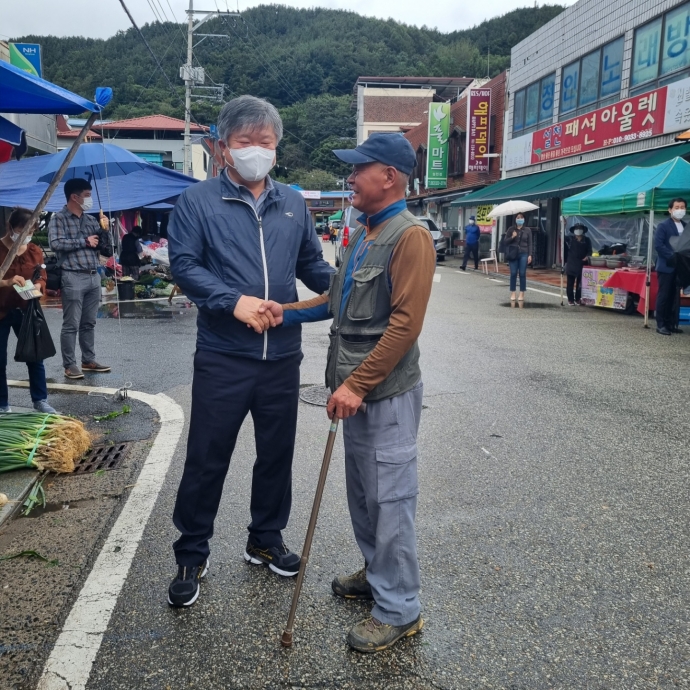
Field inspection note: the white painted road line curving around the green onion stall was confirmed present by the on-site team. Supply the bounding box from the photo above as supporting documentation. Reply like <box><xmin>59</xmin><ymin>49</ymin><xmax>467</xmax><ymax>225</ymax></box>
<box><xmin>14</xmin><ymin>381</ymin><xmax>184</xmax><ymax>690</ymax></box>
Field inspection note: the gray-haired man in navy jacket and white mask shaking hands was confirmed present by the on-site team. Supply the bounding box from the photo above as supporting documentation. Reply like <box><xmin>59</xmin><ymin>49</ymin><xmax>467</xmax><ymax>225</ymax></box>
<box><xmin>168</xmin><ymin>96</ymin><xmax>334</xmax><ymax>606</ymax></box>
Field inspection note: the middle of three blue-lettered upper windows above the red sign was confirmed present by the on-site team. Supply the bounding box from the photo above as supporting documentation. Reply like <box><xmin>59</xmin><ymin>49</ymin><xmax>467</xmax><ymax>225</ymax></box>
<box><xmin>559</xmin><ymin>36</ymin><xmax>624</xmax><ymax>120</ymax></box>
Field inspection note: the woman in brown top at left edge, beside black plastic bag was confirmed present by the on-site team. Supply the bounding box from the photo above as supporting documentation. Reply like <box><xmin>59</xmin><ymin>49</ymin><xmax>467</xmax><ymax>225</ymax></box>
<box><xmin>0</xmin><ymin>208</ymin><xmax>55</xmax><ymax>414</ymax></box>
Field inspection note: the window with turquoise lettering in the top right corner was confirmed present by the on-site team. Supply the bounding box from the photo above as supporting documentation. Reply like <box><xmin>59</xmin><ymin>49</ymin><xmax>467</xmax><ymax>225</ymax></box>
<box><xmin>630</xmin><ymin>2</ymin><xmax>690</xmax><ymax>95</ymax></box>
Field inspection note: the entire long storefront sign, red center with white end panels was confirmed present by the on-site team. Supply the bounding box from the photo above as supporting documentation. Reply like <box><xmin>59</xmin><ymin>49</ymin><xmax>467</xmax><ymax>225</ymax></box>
<box><xmin>505</xmin><ymin>78</ymin><xmax>690</xmax><ymax>170</ymax></box>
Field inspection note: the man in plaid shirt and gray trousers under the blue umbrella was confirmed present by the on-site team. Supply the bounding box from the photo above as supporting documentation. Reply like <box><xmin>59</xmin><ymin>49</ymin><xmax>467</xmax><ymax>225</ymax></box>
<box><xmin>48</xmin><ymin>178</ymin><xmax>110</xmax><ymax>379</ymax></box>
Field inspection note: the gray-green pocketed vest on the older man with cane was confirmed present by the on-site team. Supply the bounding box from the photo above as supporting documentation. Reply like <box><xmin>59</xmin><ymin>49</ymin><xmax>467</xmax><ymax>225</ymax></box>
<box><xmin>326</xmin><ymin>211</ymin><xmax>422</xmax><ymax>402</ymax></box>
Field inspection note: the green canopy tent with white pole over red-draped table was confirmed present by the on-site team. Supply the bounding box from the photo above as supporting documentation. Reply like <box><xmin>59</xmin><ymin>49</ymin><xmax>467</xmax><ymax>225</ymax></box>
<box><xmin>561</xmin><ymin>158</ymin><xmax>690</xmax><ymax>328</ymax></box>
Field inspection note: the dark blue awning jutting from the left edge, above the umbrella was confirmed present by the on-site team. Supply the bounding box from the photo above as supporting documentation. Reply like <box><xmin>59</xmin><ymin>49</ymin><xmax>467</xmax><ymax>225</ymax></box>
<box><xmin>0</xmin><ymin>61</ymin><xmax>113</xmax><ymax>115</ymax></box>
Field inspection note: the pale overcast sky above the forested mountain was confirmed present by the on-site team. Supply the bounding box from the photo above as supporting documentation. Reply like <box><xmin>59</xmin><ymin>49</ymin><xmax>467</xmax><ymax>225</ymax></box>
<box><xmin>0</xmin><ymin>0</ymin><xmax>575</xmax><ymax>40</ymax></box>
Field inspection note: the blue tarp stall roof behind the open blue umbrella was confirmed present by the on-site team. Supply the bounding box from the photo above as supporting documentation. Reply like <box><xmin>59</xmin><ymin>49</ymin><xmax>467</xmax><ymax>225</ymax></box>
<box><xmin>0</xmin><ymin>154</ymin><xmax>197</xmax><ymax>212</ymax></box>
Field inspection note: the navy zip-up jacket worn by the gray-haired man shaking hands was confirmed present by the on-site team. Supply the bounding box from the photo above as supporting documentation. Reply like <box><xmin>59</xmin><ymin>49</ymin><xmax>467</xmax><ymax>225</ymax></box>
<box><xmin>168</xmin><ymin>173</ymin><xmax>334</xmax><ymax>360</ymax></box>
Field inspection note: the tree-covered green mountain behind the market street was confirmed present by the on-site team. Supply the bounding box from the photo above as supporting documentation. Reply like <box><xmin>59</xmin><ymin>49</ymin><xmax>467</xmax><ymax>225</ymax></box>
<box><xmin>14</xmin><ymin>5</ymin><xmax>564</xmax><ymax>188</ymax></box>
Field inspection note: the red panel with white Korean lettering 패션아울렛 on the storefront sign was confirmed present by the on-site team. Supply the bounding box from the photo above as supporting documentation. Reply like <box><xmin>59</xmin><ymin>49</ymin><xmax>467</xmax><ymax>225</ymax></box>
<box><xmin>532</xmin><ymin>86</ymin><xmax>667</xmax><ymax>165</ymax></box>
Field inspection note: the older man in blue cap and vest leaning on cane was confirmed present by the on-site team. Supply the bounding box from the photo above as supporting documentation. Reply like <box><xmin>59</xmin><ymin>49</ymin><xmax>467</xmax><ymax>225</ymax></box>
<box><xmin>267</xmin><ymin>134</ymin><xmax>436</xmax><ymax>652</ymax></box>
